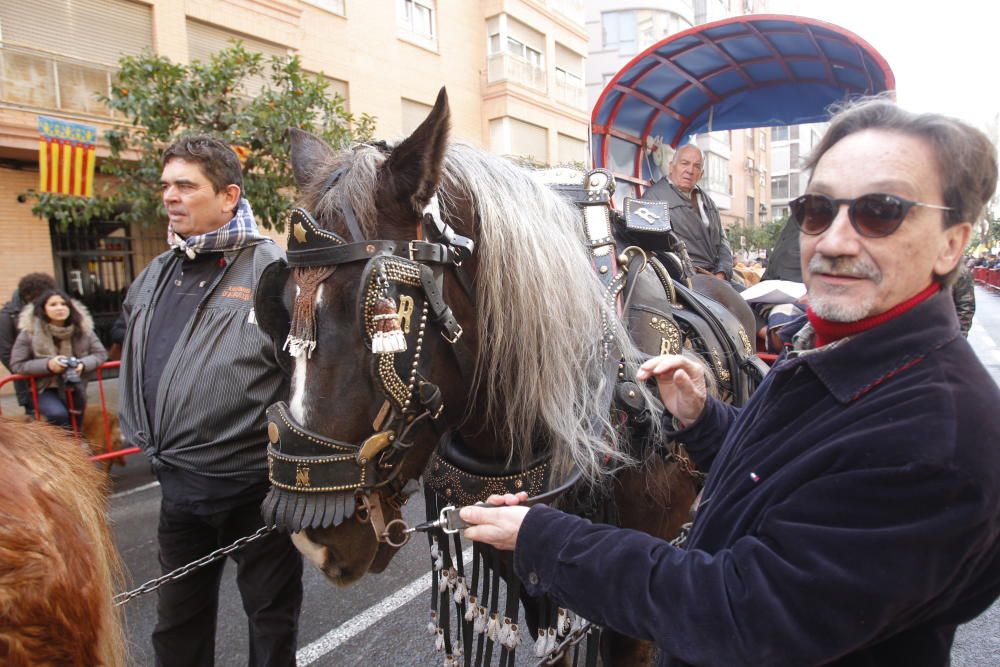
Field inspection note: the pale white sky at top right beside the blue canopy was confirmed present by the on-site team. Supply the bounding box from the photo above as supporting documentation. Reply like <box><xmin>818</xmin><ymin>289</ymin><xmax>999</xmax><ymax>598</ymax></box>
<box><xmin>767</xmin><ymin>0</ymin><xmax>1000</xmax><ymax>130</ymax></box>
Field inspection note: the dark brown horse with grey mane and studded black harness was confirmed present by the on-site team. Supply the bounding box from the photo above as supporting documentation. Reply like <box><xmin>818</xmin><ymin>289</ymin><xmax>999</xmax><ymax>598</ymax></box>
<box><xmin>254</xmin><ymin>89</ymin><xmax>760</xmax><ymax>664</ymax></box>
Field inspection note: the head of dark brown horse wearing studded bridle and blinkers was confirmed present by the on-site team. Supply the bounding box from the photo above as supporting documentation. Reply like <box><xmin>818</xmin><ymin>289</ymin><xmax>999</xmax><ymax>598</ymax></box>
<box><xmin>257</xmin><ymin>90</ymin><xmax>477</xmax><ymax>584</ymax></box>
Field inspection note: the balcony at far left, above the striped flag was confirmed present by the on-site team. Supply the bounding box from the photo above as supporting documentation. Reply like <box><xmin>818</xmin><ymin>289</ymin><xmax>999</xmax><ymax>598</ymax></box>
<box><xmin>0</xmin><ymin>44</ymin><xmax>116</xmax><ymax>117</ymax></box>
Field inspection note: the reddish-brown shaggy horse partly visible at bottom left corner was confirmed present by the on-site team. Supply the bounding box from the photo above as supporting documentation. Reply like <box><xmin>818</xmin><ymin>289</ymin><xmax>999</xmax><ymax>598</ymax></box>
<box><xmin>0</xmin><ymin>418</ymin><xmax>126</xmax><ymax>667</ymax></box>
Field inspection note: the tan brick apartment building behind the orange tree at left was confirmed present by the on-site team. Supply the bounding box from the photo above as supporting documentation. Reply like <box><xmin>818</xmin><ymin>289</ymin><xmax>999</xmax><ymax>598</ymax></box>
<box><xmin>0</xmin><ymin>0</ymin><xmax>589</xmax><ymax>352</ymax></box>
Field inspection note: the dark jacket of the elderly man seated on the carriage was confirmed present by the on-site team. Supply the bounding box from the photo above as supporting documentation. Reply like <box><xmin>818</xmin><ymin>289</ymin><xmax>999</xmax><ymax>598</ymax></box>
<box><xmin>642</xmin><ymin>178</ymin><xmax>733</xmax><ymax>280</ymax></box>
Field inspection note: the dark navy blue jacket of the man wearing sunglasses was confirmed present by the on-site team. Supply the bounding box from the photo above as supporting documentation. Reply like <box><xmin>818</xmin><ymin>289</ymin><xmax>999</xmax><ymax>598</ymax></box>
<box><xmin>515</xmin><ymin>292</ymin><xmax>1000</xmax><ymax>667</ymax></box>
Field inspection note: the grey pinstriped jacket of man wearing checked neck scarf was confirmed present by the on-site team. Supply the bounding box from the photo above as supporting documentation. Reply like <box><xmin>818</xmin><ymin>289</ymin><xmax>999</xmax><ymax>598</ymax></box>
<box><xmin>119</xmin><ymin>243</ymin><xmax>288</xmax><ymax>480</ymax></box>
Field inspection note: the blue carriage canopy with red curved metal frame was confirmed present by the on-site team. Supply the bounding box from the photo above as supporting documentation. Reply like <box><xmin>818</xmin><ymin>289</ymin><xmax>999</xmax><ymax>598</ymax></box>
<box><xmin>591</xmin><ymin>15</ymin><xmax>895</xmax><ymax>193</ymax></box>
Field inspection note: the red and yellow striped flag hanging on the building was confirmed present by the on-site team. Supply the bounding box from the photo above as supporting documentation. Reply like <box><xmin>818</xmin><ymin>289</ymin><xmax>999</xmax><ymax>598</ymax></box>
<box><xmin>38</xmin><ymin>116</ymin><xmax>97</xmax><ymax>197</ymax></box>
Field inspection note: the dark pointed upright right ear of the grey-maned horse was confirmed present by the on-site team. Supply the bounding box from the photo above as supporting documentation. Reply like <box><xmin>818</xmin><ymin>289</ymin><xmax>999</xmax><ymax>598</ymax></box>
<box><xmin>384</xmin><ymin>88</ymin><xmax>451</xmax><ymax>211</ymax></box>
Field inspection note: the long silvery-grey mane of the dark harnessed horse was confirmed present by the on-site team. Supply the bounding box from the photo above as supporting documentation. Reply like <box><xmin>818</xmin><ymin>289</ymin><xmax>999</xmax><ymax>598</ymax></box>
<box><xmin>303</xmin><ymin>143</ymin><xmax>662</xmax><ymax>482</ymax></box>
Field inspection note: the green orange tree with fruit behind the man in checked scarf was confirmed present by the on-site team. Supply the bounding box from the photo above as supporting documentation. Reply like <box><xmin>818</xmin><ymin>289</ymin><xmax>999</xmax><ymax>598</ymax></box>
<box><xmin>24</xmin><ymin>42</ymin><xmax>375</xmax><ymax>231</ymax></box>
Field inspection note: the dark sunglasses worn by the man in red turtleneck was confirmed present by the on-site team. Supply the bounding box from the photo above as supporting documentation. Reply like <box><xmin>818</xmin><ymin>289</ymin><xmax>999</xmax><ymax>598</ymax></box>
<box><xmin>788</xmin><ymin>193</ymin><xmax>954</xmax><ymax>238</ymax></box>
